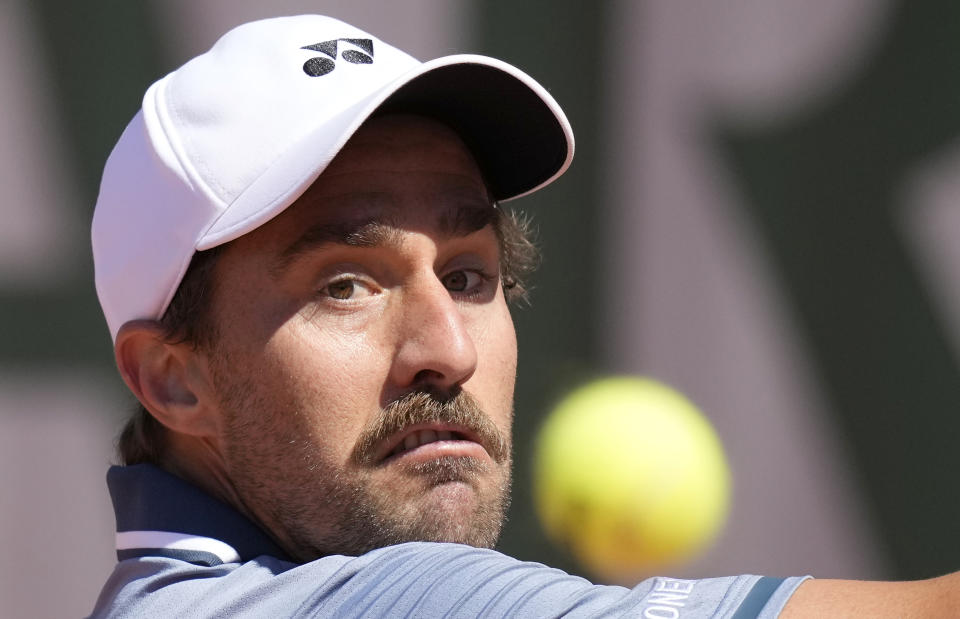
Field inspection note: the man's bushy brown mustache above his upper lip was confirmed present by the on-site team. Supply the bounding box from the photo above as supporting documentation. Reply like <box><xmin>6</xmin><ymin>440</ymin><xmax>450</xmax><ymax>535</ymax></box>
<box><xmin>352</xmin><ymin>390</ymin><xmax>510</xmax><ymax>466</ymax></box>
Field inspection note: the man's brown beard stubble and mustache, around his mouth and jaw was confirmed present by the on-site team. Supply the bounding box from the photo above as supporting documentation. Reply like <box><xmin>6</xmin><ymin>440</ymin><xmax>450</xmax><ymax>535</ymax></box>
<box><xmin>215</xmin><ymin>373</ymin><xmax>511</xmax><ymax>561</ymax></box>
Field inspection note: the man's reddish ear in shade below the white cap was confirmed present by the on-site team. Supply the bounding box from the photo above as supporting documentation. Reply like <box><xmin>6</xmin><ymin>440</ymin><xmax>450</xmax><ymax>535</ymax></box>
<box><xmin>114</xmin><ymin>320</ymin><xmax>218</xmax><ymax>437</ymax></box>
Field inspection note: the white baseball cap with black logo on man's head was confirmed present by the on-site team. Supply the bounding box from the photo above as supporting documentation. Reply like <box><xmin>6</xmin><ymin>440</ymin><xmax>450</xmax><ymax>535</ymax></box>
<box><xmin>92</xmin><ymin>15</ymin><xmax>574</xmax><ymax>339</ymax></box>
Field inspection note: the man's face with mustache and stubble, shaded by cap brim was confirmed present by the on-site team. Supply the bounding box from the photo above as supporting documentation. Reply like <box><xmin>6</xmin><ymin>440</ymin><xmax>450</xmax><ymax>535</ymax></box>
<box><xmin>203</xmin><ymin>116</ymin><xmax>517</xmax><ymax>560</ymax></box>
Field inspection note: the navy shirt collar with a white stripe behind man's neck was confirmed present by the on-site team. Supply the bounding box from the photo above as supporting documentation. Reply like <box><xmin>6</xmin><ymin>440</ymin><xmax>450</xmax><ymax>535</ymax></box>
<box><xmin>107</xmin><ymin>464</ymin><xmax>290</xmax><ymax>566</ymax></box>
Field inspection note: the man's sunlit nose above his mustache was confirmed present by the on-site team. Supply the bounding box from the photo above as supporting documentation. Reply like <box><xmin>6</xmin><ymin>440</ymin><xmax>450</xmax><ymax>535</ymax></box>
<box><xmin>392</xmin><ymin>274</ymin><xmax>477</xmax><ymax>390</ymax></box>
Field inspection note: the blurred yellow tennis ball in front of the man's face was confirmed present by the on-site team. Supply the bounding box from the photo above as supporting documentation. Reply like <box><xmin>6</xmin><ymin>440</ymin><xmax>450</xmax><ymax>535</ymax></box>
<box><xmin>534</xmin><ymin>377</ymin><xmax>730</xmax><ymax>582</ymax></box>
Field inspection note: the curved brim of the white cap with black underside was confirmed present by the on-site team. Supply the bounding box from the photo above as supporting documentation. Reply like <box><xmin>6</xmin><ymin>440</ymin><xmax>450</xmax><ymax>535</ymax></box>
<box><xmin>197</xmin><ymin>55</ymin><xmax>574</xmax><ymax>250</ymax></box>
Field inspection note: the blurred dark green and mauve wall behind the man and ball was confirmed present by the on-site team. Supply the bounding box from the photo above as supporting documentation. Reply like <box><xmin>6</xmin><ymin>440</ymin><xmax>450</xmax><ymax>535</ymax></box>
<box><xmin>0</xmin><ymin>0</ymin><xmax>960</xmax><ymax>617</ymax></box>
